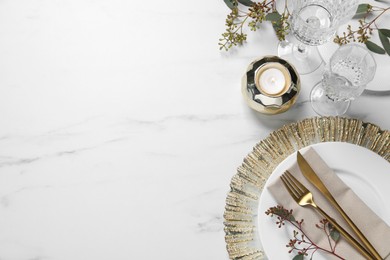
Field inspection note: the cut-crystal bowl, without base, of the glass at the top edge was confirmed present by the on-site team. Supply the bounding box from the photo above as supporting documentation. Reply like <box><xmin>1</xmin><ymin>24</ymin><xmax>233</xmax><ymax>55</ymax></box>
<box><xmin>291</xmin><ymin>0</ymin><xmax>358</xmax><ymax>46</ymax></box>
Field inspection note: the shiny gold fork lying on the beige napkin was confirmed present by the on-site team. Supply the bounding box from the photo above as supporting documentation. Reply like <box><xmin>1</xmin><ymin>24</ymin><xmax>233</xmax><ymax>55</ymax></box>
<box><xmin>280</xmin><ymin>171</ymin><xmax>374</xmax><ymax>259</ymax></box>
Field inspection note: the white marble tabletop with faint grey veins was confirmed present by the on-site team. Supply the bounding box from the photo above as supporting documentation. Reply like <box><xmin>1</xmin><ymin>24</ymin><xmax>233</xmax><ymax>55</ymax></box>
<box><xmin>0</xmin><ymin>0</ymin><xmax>390</xmax><ymax>260</ymax></box>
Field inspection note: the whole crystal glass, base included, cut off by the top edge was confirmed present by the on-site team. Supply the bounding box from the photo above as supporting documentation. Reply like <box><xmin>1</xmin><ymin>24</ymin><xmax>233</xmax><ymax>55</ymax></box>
<box><xmin>278</xmin><ymin>0</ymin><xmax>359</xmax><ymax>74</ymax></box>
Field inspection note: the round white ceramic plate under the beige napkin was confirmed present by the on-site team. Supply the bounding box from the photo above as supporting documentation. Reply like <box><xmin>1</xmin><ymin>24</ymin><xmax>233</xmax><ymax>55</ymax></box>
<box><xmin>259</xmin><ymin>143</ymin><xmax>390</xmax><ymax>260</ymax></box>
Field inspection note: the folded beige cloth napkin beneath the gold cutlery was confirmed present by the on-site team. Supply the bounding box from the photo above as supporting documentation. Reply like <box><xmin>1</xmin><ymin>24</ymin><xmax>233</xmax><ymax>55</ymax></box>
<box><xmin>268</xmin><ymin>148</ymin><xmax>390</xmax><ymax>260</ymax></box>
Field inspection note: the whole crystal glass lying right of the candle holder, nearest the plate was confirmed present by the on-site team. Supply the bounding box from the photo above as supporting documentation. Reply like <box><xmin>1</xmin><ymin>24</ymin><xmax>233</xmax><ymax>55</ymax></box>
<box><xmin>310</xmin><ymin>44</ymin><xmax>376</xmax><ymax>116</ymax></box>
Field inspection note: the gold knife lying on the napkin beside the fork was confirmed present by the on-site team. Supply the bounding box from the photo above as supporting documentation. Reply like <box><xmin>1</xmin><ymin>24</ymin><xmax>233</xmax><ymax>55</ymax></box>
<box><xmin>297</xmin><ymin>152</ymin><xmax>382</xmax><ymax>260</ymax></box>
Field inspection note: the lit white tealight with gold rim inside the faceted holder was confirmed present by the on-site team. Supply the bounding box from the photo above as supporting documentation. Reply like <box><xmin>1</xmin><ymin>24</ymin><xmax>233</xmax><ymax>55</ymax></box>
<box><xmin>256</xmin><ymin>62</ymin><xmax>291</xmax><ymax>97</ymax></box>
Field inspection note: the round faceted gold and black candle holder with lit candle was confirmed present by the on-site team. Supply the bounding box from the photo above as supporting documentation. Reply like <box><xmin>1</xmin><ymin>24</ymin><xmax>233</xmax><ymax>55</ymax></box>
<box><xmin>242</xmin><ymin>56</ymin><xmax>301</xmax><ymax>115</ymax></box>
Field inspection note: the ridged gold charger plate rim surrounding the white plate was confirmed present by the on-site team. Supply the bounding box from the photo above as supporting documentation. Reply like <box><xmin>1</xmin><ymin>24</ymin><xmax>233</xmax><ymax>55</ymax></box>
<box><xmin>224</xmin><ymin>117</ymin><xmax>390</xmax><ymax>260</ymax></box>
